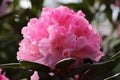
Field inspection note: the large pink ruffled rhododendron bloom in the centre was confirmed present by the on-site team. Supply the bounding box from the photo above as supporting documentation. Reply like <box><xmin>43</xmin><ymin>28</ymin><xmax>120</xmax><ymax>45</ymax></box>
<box><xmin>17</xmin><ymin>6</ymin><xmax>104</xmax><ymax>68</ymax></box>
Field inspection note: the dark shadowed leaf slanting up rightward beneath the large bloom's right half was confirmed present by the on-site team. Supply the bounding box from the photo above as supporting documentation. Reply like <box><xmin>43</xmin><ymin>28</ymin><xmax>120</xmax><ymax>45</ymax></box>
<box><xmin>67</xmin><ymin>63</ymin><xmax>91</xmax><ymax>77</ymax></box>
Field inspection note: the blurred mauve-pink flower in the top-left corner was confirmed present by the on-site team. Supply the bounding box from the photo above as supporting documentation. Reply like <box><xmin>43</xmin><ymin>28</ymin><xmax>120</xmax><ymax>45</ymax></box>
<box><xmin>0</xmin><ymin>0</ymin><xmax>10</xmax><ymax>17</ymax></box>
